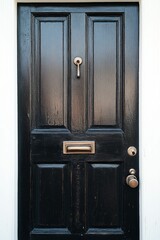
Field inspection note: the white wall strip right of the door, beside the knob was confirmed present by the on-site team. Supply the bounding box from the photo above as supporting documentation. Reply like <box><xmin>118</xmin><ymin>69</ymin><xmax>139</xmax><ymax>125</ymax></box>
<box><xmin>140</xmin><ymin>0</ymin><xmax>160</xmax><ymax>240</ymax></box>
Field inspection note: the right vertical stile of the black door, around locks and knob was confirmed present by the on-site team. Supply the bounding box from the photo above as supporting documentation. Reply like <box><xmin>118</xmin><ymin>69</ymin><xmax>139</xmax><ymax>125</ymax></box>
<box><xmin>123</xmin><ymin>7</ymin><xmax>139</xmax><ymax>239</ymax></box>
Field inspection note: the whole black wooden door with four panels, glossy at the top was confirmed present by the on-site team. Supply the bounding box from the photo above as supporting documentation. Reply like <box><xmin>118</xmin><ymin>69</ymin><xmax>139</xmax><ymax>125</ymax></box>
<box><xmin>18</xmin><ymin>4</ymin><xmax>139</xmax><ymax>240</ymax></box>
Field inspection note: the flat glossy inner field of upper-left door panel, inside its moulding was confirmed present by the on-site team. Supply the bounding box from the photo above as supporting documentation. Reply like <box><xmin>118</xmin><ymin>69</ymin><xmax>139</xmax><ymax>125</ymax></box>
<box><xmin>39</xmin><ymin>19</ymin><xmax>67</xmax><ymax>126</ymax></box>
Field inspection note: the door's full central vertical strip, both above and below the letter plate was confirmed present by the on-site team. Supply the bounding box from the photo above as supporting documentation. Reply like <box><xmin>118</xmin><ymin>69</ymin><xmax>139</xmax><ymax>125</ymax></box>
<box><xmin>70</xmin><ymin>13</ymin><xmax>87</xmax><ymax>234</ymax></box>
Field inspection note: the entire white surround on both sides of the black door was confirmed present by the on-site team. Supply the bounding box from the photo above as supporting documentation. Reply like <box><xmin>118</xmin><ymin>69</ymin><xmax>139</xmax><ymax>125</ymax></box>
<box><xmin>0</xmin><ymin>0</ymin><xmax>160</xmax><ymax>240</ymax></box>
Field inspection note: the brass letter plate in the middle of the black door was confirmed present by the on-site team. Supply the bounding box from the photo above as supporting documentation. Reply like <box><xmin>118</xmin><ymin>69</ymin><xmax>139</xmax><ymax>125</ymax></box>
<box><xmin>63</xmin><ymin>141</ymin><xmax>95</xmax><ymax>154</ymax></box>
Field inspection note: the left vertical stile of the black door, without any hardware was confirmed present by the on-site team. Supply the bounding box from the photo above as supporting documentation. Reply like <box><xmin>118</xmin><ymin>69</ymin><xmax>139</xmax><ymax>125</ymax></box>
<box><xmin>18</xmin><ymin>7</ymin><xmax>31</xmax><ymax>240</ymax></box>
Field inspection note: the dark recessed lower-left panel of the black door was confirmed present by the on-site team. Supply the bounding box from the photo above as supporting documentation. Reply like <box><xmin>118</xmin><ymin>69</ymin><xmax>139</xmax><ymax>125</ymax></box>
<box><xmin>33</xmin><ymin>164</ymin><xmax>70</xmax><ymax>228</ymax></box>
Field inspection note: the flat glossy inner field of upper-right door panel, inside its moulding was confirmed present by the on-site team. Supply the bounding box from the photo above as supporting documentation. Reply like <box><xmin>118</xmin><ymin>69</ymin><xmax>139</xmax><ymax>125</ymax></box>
<box><xmin>93</xmin><ymin>22</ymin><xmax>116</xmax><ymax>125</ymax></box>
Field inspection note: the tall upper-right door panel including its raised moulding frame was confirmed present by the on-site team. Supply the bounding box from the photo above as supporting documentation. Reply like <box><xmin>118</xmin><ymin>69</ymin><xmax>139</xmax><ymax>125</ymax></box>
<box><xmin>88</xmin><ymin>15</ymin><xmax>123</xmax><ymax>127</ymax></box>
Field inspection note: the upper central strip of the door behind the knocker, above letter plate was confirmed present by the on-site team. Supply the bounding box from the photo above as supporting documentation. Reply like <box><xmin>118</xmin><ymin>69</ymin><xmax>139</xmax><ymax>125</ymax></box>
<box><xmin>71</xmin><ymin>13</ymin><xmax>87</xmax><ymax>133</ymax></box>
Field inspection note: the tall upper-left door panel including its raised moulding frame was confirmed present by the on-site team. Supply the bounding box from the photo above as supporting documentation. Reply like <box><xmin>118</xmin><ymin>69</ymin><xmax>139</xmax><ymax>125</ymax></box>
<box><xmin>32</xmin><ymin>15</ymin><xmax>69</xmax><ymax>128</ymax></box>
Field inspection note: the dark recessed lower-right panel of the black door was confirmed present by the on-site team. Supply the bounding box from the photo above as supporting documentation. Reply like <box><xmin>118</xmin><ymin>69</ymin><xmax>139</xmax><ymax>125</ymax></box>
<box><xmin>88</xmin><ymin>163</ymin><xmax>123</xmax><ymax>229</ymax></box>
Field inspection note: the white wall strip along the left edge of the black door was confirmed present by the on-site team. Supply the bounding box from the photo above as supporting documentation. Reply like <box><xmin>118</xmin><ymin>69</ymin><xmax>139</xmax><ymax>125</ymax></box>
<box><xmin>0</xmin><ymin>0</ymin><xmax>17</xmax><ymax>240</ymax></box>
